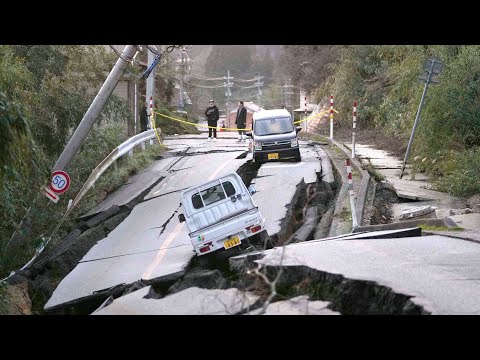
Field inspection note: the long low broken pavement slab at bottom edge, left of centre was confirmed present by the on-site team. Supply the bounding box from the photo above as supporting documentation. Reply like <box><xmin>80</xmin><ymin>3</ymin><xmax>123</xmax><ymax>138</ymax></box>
<box><xmin>92</xmin><ymin>286</ymin><xmax>258</xmax><ymax>315</ymax></box>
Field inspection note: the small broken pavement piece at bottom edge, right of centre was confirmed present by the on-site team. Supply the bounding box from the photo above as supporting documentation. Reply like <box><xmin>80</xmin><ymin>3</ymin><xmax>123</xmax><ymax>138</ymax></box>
<box><xmin>245</xmin><ymin>295</ymin><xmax>341</xmax><ymax>315</ymax></box>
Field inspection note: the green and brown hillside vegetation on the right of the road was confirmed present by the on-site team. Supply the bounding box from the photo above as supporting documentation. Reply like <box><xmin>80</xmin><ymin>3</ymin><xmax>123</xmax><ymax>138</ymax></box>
<box><xmin>280</xmin><ymin>45</ymin><xmax>480</xmax><ymax>196</ymax></box>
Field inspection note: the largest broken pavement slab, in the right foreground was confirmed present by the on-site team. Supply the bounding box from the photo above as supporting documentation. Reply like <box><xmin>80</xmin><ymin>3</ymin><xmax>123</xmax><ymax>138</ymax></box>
<box><xmin>256</xmin><ymin>236</ymin><xmax>480</xmax><ymax>315</ymax></box>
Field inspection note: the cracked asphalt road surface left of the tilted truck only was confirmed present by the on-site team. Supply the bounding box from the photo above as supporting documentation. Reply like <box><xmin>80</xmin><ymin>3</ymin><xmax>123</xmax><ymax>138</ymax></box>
<box><xmin>45</xmin><ymin>137</ymin><xmax>248</xmax><ymax>310</ymax></box>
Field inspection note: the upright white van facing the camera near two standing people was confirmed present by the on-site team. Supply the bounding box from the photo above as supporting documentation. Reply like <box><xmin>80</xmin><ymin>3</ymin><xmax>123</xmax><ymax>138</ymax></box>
<box><xmin>246</xmin><ymin>109</ymin><xmax>302</xmax><ymax>162</ymax></box>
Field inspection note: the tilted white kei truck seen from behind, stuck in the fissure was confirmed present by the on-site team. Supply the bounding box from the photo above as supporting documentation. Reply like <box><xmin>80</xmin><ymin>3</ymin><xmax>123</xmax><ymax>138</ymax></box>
<box><xmin>178</xmin><ymin>172</ymin><xmax>268</xmax><ymax>256</ymax></box>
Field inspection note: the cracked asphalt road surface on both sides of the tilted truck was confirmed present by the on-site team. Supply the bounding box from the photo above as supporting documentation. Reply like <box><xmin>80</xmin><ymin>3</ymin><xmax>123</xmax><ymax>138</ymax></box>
<box><xmin>44</xmin><ymin>135</ymin><xmax>320</xmax><ymax>310</ymax></box>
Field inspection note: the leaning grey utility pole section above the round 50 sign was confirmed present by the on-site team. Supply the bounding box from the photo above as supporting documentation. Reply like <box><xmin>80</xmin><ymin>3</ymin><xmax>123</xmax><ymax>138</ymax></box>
<box><xmin>53</xmin><ymin>45</ymin><xmax>137</xmax><ymax>171</ymax></box>
